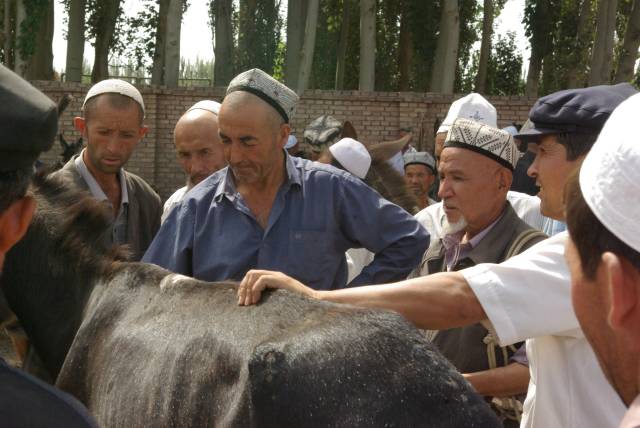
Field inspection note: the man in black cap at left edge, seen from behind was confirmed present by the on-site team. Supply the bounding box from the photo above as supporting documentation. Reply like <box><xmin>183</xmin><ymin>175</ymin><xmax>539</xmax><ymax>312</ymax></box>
<box><xmin>0</xmin><ymin>65</ymin><xmax>96</xmax><ymax>428</ymax></box>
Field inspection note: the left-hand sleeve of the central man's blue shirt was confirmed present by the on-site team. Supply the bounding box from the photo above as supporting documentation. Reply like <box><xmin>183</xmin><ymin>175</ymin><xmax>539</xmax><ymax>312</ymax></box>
<box><xmin>142</xmin><ymin>199</ymin><xmax>195</xmax><ymax>276</ymax></box>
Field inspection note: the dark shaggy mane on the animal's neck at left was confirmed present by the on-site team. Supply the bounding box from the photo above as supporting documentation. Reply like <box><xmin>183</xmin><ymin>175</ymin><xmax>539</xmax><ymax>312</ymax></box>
<box><xmin>30</xmin><ymin>171</ymin><xmax>130</xmax><ymax>272</ymax></box>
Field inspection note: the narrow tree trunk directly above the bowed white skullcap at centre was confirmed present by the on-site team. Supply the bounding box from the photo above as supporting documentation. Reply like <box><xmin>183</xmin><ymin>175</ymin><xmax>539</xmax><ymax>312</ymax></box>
<box><xmin>358</xmin><ymin>0</ymin><xmax>376</xmax><ymax>91</ymax></box>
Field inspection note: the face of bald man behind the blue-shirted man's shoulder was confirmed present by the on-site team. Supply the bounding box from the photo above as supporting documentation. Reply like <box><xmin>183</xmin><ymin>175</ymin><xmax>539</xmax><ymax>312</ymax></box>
<box><xmin>173</xmin><ymin>110</ymin><xmax>226</xmax><ymax>186</ymax></box>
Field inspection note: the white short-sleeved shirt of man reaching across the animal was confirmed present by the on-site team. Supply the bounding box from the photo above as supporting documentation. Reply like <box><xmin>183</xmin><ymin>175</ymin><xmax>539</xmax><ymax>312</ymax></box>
<box><xmin>461</xmin><ymin>233</ymin><xmax>625</xmax><ymax>428</ymax></box>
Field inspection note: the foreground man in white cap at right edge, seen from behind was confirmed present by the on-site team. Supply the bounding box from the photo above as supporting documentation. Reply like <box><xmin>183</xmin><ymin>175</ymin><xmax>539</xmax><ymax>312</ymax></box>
<box><xmin>565</xmin><ymin>95</ymin><xmax>640</xmax><ymax>428</ymax></box>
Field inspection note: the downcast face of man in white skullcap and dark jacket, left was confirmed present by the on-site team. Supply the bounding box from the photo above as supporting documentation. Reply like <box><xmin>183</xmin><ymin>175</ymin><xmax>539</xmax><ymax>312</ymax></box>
<box><xmin>74</xmin><ymin>96</ymin><xmax>147</xmax><ymax>175</ymax></box>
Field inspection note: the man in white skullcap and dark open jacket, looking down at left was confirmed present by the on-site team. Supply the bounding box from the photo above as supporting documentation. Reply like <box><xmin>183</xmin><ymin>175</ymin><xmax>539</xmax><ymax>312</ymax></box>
<box><xmin>55</xmin><ymin>79</ymin><xmax>162</xmax><ymax>260</ymax></box>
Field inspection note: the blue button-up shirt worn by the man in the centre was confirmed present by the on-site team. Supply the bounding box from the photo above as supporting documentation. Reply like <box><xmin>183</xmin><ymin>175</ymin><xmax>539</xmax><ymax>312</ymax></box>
<box><xmin>143</xmin><ymin>155</ymin><xmax>429</xmax><ymax>290</ymax></box>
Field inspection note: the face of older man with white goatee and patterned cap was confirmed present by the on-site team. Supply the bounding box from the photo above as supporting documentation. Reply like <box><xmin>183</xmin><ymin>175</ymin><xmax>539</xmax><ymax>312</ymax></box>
<box><xmin>438</xmin><ymin>147</ymin><xmax>508</xmax><ymax>231</ymax></box>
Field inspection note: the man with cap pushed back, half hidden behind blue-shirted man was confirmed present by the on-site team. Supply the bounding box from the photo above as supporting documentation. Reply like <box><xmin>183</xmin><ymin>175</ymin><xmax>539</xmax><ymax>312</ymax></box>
<box><xmin>162</xmin><ymin>100</ymin><xmax>226</xmax><ymax>222</ymax></box>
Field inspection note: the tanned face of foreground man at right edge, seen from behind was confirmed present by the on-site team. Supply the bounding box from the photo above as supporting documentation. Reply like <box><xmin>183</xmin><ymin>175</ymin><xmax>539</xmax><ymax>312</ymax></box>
<box><xmin>565</xmin><ymin>239</ymin><xmax>638</xmax><ymax>405</ymax></box>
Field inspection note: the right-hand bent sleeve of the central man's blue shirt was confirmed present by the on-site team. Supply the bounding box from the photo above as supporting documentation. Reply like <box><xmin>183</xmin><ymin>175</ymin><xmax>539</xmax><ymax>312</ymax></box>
<box><xmin>340</xmin><ymin>181</ymin><xmax>429</xmax><ymax>287</ymax></box>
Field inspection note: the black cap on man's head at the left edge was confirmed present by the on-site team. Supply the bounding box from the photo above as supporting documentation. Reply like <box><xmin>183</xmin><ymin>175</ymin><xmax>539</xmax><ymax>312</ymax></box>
<box><xmin>0</xmin><ymin>65</ymin><xmax>58</xmax><ymax>172</ymax></box>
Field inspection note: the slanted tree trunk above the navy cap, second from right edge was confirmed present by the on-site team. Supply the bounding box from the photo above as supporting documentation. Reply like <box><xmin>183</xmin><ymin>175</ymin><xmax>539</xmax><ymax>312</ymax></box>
<box><xmin>589</xmin><ymin>0</ymin><xmax>618</xmax><ymax>86</ymax></box>
